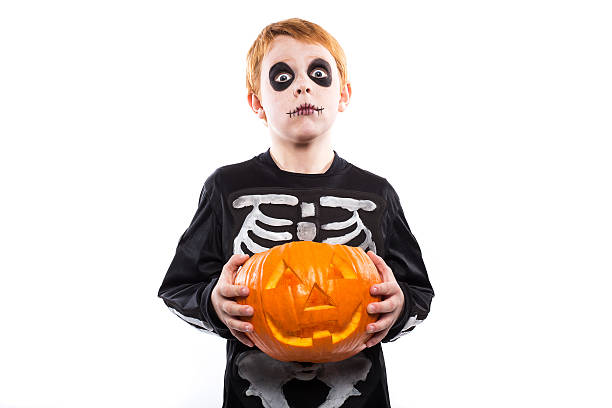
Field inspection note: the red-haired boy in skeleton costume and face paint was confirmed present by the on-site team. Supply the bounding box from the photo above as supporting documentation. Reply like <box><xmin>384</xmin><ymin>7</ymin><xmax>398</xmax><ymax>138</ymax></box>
<box><xmin>158</xmin><ymin>18</ymin><xmax>434</xmax><ymax>408</ymax></box>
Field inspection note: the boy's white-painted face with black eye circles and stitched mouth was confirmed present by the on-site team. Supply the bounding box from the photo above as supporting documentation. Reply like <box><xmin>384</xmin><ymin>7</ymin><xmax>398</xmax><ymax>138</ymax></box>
<box><xmin>249</xmin><ymin>35</ymin><xmax>350</xmax><ymax>143</ymax></box>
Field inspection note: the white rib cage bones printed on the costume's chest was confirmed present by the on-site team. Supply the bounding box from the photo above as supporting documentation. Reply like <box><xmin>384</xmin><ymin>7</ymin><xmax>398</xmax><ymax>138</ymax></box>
<box><xmin>232</xmin><ymin>194</ymin><xmax>376</xmax><ymax>254</ymax></box>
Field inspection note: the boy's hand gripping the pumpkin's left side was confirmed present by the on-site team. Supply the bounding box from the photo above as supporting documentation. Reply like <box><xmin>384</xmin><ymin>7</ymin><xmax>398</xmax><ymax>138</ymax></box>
<box><xmin>210</xmin><ymin>254</ymin><xmax>253</xmax><ymax>347</ymax></box>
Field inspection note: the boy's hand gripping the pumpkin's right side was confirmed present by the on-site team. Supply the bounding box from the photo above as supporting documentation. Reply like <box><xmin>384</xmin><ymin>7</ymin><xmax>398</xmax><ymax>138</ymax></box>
<box><xmin>366</xmin><ymin>251</ymin><xmax>404</xmax><ymax>347</ymax></box>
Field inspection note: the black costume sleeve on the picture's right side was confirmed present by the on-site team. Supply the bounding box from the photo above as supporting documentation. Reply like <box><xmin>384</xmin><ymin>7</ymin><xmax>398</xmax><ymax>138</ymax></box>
<box><xmin>382</xmin><ymin>184</ymin><xmax>434</xmax><ymax>343</ymax></box>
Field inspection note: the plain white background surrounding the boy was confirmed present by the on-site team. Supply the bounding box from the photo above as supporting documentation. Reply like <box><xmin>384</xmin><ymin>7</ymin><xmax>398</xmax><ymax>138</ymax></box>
<box><xmin>0</xmin><ymin>0</ymin><xmax>612</xmax><ymax>408</ymax></box>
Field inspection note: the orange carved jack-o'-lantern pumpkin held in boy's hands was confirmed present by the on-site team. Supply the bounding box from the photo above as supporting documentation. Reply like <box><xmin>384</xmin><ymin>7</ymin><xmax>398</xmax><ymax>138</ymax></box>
<box><xmin>234</xmin><ymin>241</ymin><xmax>381</xmax><ymax>363</ymax></box>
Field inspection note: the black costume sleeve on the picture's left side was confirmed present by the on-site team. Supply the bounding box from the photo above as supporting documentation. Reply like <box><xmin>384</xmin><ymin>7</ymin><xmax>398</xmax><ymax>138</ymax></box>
<box><xmin>157</xmin><ymin>173</ymin><xmax>234</xmax><ymax>339</ymax></box>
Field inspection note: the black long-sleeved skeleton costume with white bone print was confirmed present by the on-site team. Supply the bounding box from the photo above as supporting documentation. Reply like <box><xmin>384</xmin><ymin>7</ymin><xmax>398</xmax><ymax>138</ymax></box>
<box><xmin>158</xmin><ymin>149</ymin><xmax>434</xmax><ymax>408</ymax></box>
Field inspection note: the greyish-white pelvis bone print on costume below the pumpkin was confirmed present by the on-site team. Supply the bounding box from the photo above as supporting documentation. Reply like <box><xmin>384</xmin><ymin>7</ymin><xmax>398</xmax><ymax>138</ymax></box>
<box><xmin>235</xmin><ymin>350</ymin><xmax>372</xmax><ymax>408</ymax></box>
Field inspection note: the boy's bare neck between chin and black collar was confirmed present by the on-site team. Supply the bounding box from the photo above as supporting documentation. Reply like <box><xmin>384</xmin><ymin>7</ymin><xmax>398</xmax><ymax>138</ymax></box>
<box><xmin>270</xmin><ymin>142</ymin><xmax>334</xmax><ymax>174</ymax></box>
